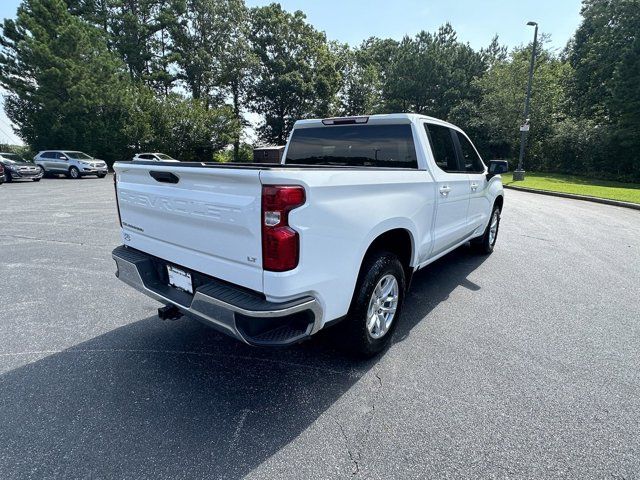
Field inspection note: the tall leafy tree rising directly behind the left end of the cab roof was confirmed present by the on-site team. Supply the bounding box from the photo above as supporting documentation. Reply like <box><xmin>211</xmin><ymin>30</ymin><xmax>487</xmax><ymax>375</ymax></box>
<box><xmin>250</xmin><ymin>4</ymin><xmax>340</xmax><ymax>144</ymax></box>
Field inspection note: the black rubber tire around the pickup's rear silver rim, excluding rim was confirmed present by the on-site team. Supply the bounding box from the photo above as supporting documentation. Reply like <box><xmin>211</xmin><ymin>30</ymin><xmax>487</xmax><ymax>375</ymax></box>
<box><xmin>338</xmin><ymin>252</ymin><xmax>406</xmax><ymax>358</ymax></box>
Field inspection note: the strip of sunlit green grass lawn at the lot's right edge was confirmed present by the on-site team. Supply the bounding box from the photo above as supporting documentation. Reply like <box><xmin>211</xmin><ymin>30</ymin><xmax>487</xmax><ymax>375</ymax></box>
<box><xmin>502</xmin><ymin>172</ymin><xmax>640</xmax><ymax>203</ymax></box>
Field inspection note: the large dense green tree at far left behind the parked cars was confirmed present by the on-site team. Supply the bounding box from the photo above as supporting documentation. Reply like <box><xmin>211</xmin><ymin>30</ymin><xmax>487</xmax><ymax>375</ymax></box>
<box><xmin>0</xmin><ymin>0</ymin><xmax>135</xmax><ymax>161</ymax></box>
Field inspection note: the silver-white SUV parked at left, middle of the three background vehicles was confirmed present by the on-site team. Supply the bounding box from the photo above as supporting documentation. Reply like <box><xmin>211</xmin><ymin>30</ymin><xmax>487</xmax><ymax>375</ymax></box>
<box><xmin>33</xmin><ymin>150</ymin><xmax>108</xmax><ymax>178</ymax></box>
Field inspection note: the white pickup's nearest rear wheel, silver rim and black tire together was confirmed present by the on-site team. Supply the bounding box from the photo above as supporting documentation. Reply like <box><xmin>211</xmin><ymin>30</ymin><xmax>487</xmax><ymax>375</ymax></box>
<box><xmin>343</xmin><ymin>252</ymin><xmax>405</xmax><ymax>357</ymax></box>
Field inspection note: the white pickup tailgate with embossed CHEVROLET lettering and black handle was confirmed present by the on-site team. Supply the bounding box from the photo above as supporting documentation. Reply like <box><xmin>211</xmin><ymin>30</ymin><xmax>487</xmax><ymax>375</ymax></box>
<box><xmin>114</xmin><ymin>163</ymin><xmax>263</xmax><ymax>292</ymax></box>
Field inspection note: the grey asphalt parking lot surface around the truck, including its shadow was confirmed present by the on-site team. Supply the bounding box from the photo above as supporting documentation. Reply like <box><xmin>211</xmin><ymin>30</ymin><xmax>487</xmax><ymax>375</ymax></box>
<box><xmin>0</xmin><ymin>176</ymin><xmax>640</xmax><ymax>479</ymax></box>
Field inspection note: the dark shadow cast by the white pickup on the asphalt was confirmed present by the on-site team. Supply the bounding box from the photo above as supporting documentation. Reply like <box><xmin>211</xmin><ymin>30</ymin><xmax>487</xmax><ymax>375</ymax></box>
<box><xmin>0</xmin><ymin>248</ymin><xmax>484</xmax><ymax>478</ymax></box>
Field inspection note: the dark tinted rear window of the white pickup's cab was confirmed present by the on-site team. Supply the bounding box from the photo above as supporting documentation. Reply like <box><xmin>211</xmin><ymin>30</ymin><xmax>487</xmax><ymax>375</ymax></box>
<box><xmin>285</xmin><ymin>124</ymin><xmax>418</xmax><ymax>168</ymax></box>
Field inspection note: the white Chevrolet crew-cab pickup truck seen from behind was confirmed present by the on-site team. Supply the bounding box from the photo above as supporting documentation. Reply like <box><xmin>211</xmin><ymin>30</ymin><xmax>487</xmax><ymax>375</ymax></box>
<box><xmin>113</xmin><ymin>114</ymin><xmax>507</xmax><ymax>355</ymax></box>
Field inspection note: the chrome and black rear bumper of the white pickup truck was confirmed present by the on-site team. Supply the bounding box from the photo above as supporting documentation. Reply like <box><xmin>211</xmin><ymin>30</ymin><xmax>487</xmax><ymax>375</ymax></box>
<box><xmin>112</xmin><ymin>246</ymin><xmax>322</xmax><ymax>346</ymax></box>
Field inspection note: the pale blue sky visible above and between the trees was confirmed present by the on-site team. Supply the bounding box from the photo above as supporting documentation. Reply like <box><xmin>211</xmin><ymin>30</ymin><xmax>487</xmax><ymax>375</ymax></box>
<box><xmin>0</xmin><ymin>0</ymin><xmax>581</xmax><ymax>144</ymax></box>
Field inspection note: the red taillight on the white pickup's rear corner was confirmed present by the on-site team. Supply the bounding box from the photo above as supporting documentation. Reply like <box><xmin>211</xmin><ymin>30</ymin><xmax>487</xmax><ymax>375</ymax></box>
<box><xmin>262</xmin><ymin>185</ymin><xmax>305</xmax><ymax>272</ymax></box>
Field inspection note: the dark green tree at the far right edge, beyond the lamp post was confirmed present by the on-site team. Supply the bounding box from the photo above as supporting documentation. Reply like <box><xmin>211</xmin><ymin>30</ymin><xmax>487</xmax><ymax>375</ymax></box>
<box><xmin>568</xmin><ymin>0</ymin><xmax>640</xmax><ymax>179</ymax></box>
